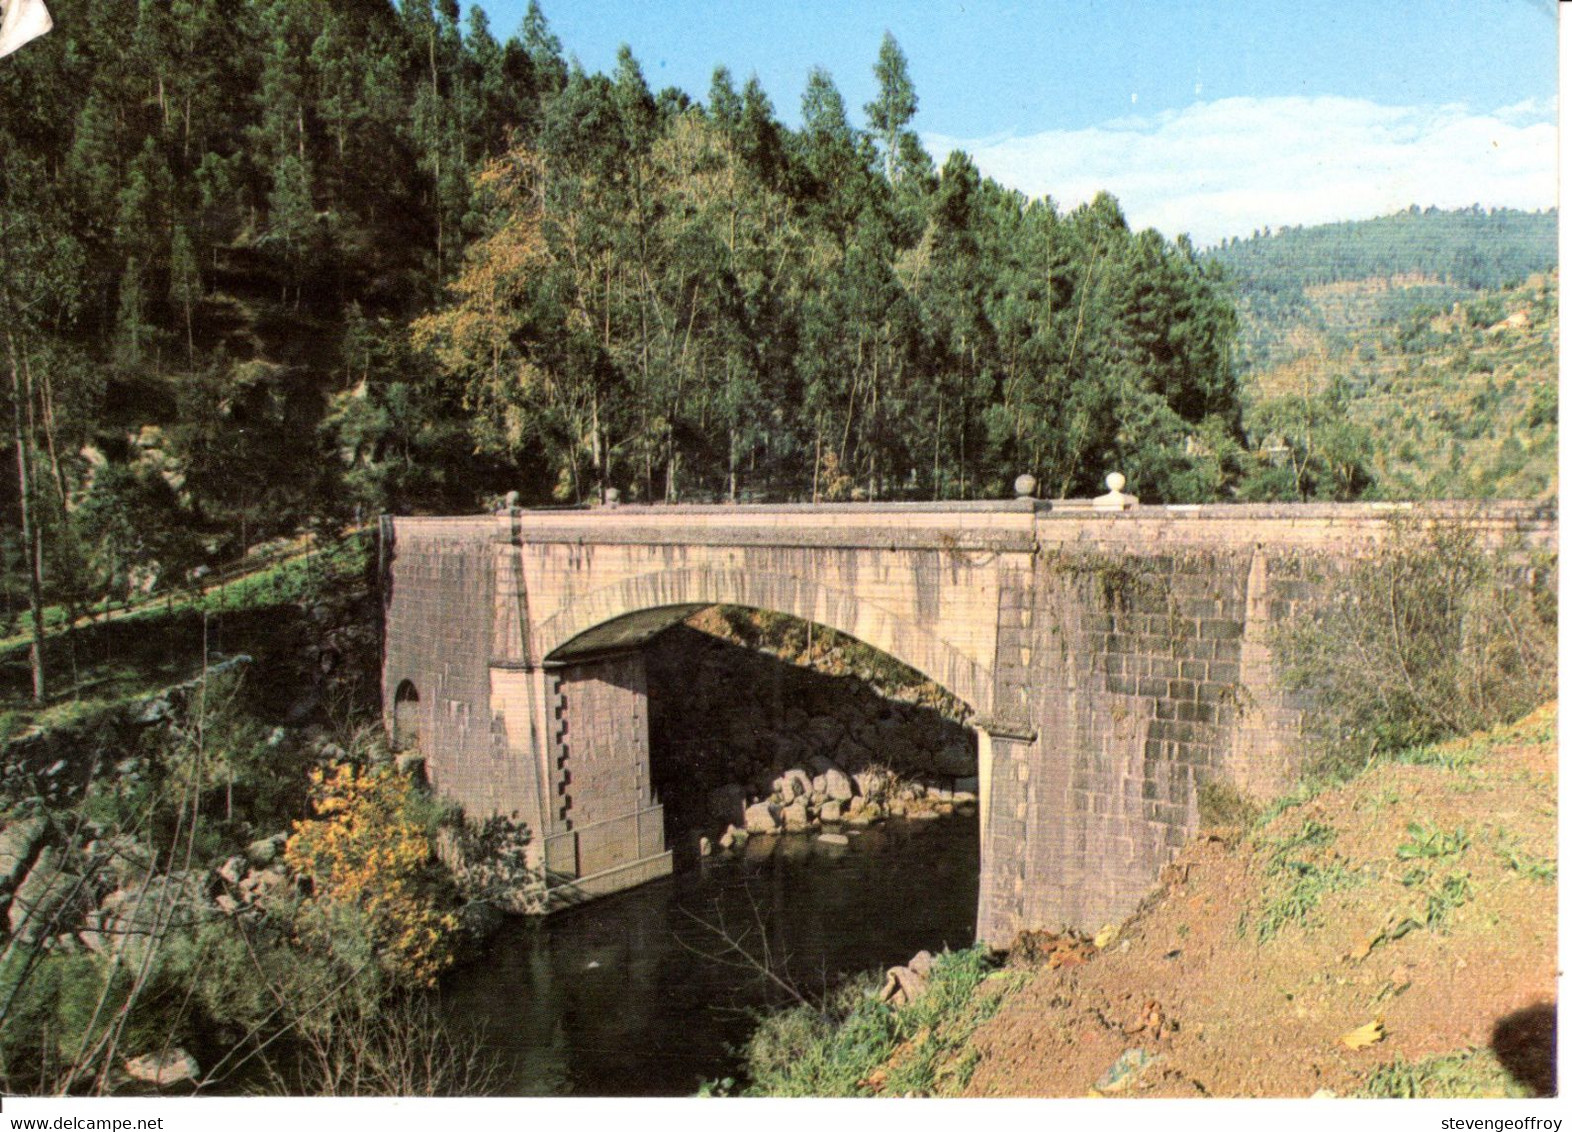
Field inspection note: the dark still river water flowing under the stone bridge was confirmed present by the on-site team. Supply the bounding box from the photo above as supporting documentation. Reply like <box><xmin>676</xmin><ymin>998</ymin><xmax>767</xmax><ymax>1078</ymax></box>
<box><xmin>443</xmin><ymin>816</ymin><xmax>978</xmax><ymax>1096</ymax></box>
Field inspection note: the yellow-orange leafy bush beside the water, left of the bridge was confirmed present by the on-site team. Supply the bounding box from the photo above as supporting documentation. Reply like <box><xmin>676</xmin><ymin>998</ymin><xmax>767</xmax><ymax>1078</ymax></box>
<box><xmin>285</xmin><ymin>764</ymin><xmax>457</xmax><ymax>986</ymax></box>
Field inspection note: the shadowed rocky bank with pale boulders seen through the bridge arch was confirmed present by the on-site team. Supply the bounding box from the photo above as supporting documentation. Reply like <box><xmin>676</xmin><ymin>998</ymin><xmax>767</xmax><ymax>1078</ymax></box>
<box><xmin>648</xmin><ymin>619</ymin><xmax>978</xmax><ymax>854</ymax></box>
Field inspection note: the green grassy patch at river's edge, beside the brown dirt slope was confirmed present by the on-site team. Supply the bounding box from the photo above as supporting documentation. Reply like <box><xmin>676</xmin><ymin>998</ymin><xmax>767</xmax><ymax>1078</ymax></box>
<box><xmin>732</xmin><ymin>946</ymin><xmax>1025</xmax><ymax>1097</ymax></box>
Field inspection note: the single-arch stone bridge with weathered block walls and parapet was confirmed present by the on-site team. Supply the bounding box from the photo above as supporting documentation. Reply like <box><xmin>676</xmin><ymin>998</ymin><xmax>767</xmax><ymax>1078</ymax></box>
<box><xmin>382</xmin><ymin>498</ymin><xmax>1555</xmax><ymax>943</ymax></box>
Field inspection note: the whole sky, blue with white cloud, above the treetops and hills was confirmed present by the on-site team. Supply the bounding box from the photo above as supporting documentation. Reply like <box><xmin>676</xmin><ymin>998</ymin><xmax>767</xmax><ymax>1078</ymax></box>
<box><xmin>483</xmin><ymin>0</ymin><xmax>1558</xmax><ymax>244</ymax></box>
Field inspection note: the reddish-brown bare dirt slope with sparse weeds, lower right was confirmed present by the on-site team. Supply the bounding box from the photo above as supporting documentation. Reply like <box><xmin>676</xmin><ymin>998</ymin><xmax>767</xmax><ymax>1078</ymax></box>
<box><xmin>968</xmin><ymin>704</ymin><xmax>1556</xmax><ymax>1097</ymax></box>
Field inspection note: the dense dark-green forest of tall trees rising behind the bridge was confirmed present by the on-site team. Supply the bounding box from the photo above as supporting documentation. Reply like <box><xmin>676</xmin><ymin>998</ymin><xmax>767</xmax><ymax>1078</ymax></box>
<box><xmin>0</xmin><ymin>0</ymin><xmax>1553</xmax><ymax>632</ymax></box>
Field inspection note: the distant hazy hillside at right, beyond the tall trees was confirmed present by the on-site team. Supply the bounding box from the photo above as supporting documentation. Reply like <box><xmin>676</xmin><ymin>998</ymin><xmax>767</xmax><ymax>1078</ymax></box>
<box><xmin>1207</xmin><ymin>209</ymin><xmax>1559</xmax><ymax>498</ymax></box>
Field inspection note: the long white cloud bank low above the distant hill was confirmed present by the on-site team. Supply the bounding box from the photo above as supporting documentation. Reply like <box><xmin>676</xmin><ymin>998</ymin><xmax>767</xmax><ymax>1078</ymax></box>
<box><xmin>923</xmin><ymin>96</ymin><xmax>1556</xmax><ymax>245</ymax></box>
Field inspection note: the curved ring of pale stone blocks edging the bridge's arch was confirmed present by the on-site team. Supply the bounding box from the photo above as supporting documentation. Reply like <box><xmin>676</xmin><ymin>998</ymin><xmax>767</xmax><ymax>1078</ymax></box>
<box><xmin>538</xmin><ymin>568</ymin><xmax>994</xmax><ymax>714</ymax></box>
